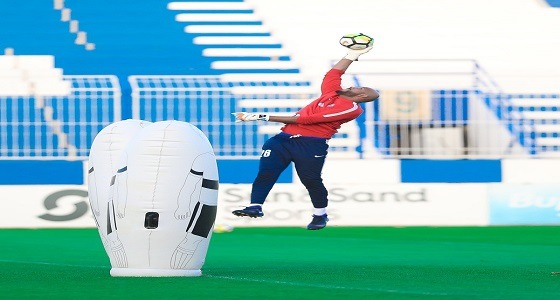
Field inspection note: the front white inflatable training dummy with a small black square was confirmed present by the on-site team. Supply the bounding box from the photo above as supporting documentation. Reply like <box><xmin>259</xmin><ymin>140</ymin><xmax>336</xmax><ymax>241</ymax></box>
<box><xmin>90</xmin><ymin>121</ymin><xmax>218</xmax><ymax>276</ymax></box>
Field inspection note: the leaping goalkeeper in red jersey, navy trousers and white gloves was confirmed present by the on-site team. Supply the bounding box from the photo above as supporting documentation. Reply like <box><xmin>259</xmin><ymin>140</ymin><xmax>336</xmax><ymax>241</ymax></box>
<box><xmin>233</xmin><ymin>46</ymin><xmax>379</xmax><ymax>230</ymax></box>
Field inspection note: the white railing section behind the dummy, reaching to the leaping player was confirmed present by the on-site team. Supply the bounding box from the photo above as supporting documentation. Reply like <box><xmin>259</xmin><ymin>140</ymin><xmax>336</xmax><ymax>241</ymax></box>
<box><xmin>129</xmin><ymin>74</ymin><xmax>315</xmax><ymax>158</ymax></box>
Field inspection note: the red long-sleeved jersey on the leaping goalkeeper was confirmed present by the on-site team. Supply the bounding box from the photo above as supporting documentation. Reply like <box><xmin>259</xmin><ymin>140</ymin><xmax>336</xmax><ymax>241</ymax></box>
<box><xmin>282</xmin><ymin>69</ymin><xmax>363</xmax><ymax>139</ymax></box>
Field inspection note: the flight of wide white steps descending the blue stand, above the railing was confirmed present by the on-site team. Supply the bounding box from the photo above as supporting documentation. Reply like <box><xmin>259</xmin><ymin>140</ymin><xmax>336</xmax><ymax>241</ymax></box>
<box><xmin>167</xmin><ymin>1</ymin><xmax>300</xmax><ymax>73</ymax></box>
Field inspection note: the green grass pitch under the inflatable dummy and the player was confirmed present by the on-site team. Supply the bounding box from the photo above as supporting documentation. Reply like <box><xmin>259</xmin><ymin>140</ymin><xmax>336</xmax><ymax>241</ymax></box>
<box><xmin>0</xmin><ymin>227</ymin><xmax>560</xmax><ymax>299</ymax></box>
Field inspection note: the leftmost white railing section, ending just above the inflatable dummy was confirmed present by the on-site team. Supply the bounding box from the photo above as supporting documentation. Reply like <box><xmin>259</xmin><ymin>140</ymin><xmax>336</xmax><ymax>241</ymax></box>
<box><xmin>0</xmin><ymin>76</ymin><xmax>121</xmax><ymax>159</ymax></box>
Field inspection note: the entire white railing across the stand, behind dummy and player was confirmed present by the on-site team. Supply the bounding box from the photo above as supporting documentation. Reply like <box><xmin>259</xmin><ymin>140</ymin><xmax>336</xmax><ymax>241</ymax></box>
<box><xmin>0</xmin><ymin>60</ymin><xmax>560</xmax><ymax>159</ymax></box>
